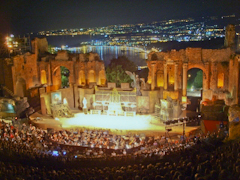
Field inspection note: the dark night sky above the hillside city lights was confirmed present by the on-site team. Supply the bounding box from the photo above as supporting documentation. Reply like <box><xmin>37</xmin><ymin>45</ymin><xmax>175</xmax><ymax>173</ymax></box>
<box><xmin>0</xmin><ymin>0</ymin><xmax>240</xmax><ymax>34</ymax></box>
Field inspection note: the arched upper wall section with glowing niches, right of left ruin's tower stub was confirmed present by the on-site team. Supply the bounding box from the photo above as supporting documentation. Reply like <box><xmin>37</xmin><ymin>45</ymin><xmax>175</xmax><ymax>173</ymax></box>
<box><xmin>38</xmin><ymin>51</ymin><xmax>106</xmax><ymax>90</ymax></box>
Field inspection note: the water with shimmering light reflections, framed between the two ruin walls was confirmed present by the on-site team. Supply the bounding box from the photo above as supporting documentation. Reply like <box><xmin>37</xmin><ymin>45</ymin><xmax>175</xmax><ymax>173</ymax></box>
<box><xmin>68</xmin><ymin>46</ymin><xmax>148</xmax><ymax>66</ymax></box>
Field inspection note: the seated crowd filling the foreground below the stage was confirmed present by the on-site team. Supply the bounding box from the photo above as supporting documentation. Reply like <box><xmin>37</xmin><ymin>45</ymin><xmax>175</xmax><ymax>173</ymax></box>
<box><xmin>0</xmin><ymin>118</ymin><xmax>236</xmax><ymax>180</ymax></box>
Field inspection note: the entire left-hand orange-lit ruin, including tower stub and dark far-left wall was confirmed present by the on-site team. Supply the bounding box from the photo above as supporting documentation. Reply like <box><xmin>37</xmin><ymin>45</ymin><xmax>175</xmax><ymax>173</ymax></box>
<box><xmin>2</xmin><ymin>38</ymin><xmax>106</xmax><ymax>113</ymax></box>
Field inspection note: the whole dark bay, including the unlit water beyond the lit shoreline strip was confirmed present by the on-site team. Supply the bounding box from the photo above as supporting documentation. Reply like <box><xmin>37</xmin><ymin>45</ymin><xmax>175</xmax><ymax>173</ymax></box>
<box><xmin>42</xmin><ymin>35</ymin><xmax>148</xmax><ymax>66</ymax></box>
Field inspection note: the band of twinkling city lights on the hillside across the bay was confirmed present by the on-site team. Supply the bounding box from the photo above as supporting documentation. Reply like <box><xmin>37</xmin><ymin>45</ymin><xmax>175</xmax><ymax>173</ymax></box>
<box><xmin>32</xmin><ymin>14</ymin><xmax>233</xmax><ymax>46</ymax></box>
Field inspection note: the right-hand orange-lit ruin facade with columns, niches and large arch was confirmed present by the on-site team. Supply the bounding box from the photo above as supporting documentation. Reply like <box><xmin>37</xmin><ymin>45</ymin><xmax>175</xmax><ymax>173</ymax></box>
<box><xmin>147</xmin><ymin>48</ymin><xmax>240</xmax><ymax>104</ymax></box>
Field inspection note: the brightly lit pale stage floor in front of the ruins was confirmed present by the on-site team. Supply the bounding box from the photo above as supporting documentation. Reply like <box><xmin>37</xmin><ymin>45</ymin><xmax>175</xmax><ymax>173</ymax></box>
<box><xmin>30</xmin><ymin>113</ymin><xmax>199</xmax><ymax>135</ymax></box>
